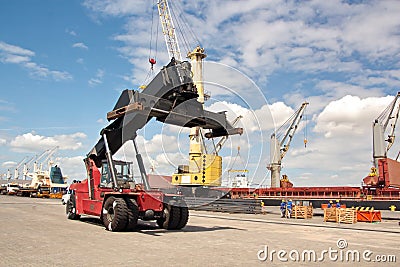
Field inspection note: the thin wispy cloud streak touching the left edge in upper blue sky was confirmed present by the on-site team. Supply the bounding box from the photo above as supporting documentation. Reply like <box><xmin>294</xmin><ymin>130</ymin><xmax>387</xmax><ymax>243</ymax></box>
<box><xmin>0</xmin><ymin>41</ymin><xmax>72</xmax><ymax>81</ymax></box>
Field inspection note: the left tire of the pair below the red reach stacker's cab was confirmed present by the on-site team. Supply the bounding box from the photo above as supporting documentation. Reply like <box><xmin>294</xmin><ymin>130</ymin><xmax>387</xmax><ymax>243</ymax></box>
<box><xmin>102</xmin><ymin>197</ymin><xmax>128</xmax><ymax>232</ymax></box>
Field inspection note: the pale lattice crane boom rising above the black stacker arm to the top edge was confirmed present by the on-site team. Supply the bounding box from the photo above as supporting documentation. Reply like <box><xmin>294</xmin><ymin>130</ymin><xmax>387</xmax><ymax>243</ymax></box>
<box><xmin>157</xmin><ymin>0</ymin><xmax>182</xmax><ymax>61</ymax></box>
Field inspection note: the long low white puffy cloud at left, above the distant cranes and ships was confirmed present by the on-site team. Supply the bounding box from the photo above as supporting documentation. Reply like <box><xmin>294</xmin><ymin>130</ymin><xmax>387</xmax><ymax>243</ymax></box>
<box><xmin>10</xmin><ymin>132</ymin><xmax>86</xmax><ymax>152</ymax></box>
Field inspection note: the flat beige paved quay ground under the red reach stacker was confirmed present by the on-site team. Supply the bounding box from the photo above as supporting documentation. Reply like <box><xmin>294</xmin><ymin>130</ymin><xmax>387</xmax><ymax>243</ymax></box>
<box><xmin>0</xmin><ymin>196</ymin><xmax>400</xmax><ymax>266</ymax></box>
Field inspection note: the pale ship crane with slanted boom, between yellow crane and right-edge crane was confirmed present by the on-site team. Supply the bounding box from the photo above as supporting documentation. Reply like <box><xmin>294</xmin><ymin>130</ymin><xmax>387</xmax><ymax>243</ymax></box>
<box><xmin>267</xmin><ymin>102</ymin><xmax>309</xmax><ymax>188</ymax></box>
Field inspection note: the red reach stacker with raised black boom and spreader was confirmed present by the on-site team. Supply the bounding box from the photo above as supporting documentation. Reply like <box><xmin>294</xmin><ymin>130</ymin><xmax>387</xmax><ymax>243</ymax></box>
<box><xmin>66</xmin><ymin>59</ymin><xmax>243</xmax><ymax>231</ymax></box>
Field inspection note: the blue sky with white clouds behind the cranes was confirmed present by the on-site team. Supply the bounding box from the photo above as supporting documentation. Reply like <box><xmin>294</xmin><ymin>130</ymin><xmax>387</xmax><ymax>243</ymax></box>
<box><xmin>0</xmin><ymin>0</ymin><xmax>400</xmax><ymax>186</ymax></box>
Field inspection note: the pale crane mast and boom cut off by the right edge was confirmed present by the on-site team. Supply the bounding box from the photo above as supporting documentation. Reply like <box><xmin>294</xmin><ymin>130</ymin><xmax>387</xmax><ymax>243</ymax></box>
<box><xmin>372</xmin><ymin>92</ymin><xmax>400</xmax><ymax>168</ymax></box>
